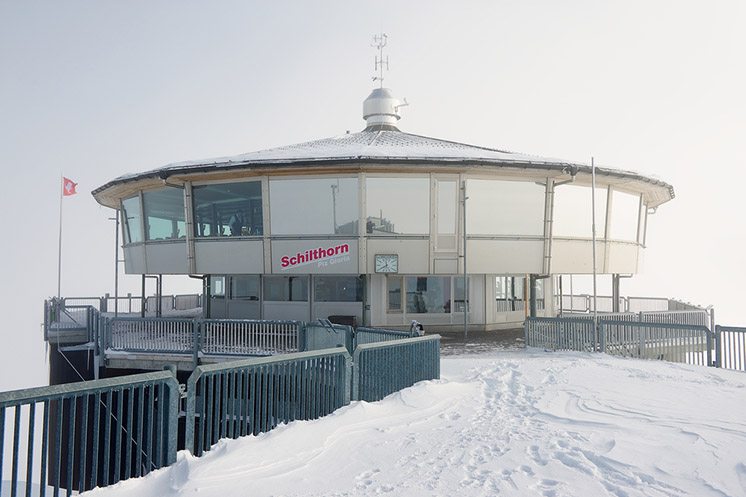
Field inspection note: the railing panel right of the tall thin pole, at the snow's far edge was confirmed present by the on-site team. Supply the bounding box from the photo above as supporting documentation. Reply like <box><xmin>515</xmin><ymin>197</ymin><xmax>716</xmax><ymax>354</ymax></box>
<box><xmin>599</xmin><ymin>320</ymin><xmax>713</xmax><ymax>366</ymax></box>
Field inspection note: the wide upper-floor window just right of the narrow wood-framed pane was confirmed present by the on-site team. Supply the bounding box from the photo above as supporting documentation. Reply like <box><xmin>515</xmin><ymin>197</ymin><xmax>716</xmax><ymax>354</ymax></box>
<box><xmin>466</xmin><ymin>179</ymin><xmax>546</xmax><ymax>236</ymax></box>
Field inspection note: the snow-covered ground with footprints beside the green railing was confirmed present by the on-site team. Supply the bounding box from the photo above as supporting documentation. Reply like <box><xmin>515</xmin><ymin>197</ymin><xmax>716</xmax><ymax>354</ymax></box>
<box><xmin>91</xmin><ymin>350</ymin><xmax>746</xmax><ymax>497</ymax></box>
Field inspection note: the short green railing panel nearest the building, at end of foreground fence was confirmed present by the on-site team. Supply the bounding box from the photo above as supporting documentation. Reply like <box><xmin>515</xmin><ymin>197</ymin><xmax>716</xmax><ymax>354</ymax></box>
<box><xmin>352</xmin><ymin>335</ymin><xmax>440</xmax><ymax>402</ymax></box>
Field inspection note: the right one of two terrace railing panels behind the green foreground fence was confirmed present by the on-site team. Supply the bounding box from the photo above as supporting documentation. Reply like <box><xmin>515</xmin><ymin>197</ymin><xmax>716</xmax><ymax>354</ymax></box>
<box><xmin>199</xmin><ymin>319</ymin><xmax>304</xmax><ymax>355</ymax></box>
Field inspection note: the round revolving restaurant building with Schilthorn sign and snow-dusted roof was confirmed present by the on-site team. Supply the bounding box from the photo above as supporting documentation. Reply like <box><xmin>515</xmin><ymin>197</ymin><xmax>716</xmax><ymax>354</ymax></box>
<box><xmin>93</xmin><ymin>88</ymin><xmax>673</xmax><ymax>331</ymax></box>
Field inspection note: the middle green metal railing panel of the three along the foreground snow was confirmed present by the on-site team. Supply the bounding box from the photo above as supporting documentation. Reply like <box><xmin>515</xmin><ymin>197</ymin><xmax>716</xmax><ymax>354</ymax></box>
<box><xmin>185</xmin><ymin>349</ymin><xmax>352</xmax><ymax>456</ymax></box>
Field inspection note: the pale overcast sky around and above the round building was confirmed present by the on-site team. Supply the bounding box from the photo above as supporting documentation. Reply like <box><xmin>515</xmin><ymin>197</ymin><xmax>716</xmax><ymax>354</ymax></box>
<box><xmin>0</xmin><ymin>0</ymin><xmax>746</xmax><ymax>386</ymax></box>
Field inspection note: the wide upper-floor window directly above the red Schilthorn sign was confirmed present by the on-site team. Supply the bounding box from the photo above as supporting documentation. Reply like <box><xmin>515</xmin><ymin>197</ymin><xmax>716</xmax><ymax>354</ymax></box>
<box><xmin>269</xmin><ymin>178</ymin><xmax>359</xmax><ymax>236</ymax></box>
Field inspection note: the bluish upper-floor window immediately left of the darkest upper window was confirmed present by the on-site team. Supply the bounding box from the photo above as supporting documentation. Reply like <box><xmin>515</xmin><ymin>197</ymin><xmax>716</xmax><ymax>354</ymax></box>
<box><xmin>142</xmin><ymin>187</ymin><xmax>186</xmax><ymax>240</ymax></box>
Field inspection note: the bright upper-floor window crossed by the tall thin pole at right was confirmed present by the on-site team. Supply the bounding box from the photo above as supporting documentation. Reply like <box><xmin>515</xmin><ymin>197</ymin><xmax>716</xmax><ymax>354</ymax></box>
<box><xmin>552</xmin><ymin>185</ymin><xmax>607</xmax><ymax>238</ymax></box>
